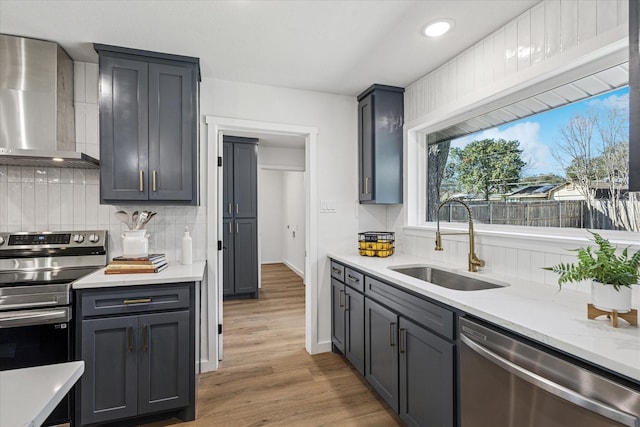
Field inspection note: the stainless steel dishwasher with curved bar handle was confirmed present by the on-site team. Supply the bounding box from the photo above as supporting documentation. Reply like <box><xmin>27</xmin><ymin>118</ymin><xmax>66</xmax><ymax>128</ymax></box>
<box><xmin>460</xmin><ymin>318</ymin><xmax>640</xmax><ymax>427</ymax></box>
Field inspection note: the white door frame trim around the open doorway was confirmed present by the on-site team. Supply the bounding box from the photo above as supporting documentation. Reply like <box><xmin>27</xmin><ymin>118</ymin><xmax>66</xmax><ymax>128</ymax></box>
<box><xmin>203</xmin><ymin>116</ymin><xmax>320</xmax><ymax>371</ymax></box>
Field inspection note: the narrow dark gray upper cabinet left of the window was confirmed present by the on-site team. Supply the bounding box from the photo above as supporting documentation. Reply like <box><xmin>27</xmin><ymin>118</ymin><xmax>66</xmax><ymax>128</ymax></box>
<box><xmin>358</xmin><ymin>84</ymin><xmax>404</xmax><ymax>204</ymax></box>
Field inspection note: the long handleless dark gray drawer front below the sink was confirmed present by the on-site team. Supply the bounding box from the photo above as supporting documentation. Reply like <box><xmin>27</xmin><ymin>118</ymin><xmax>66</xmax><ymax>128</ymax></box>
<box><xmin>365</xmin><ymin>276</ymin><xmax>454</xmax><ymax>340</ymax></box>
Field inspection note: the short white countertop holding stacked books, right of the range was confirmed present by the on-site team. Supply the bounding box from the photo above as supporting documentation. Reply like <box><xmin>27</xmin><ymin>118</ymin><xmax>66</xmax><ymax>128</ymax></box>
<box><xmin>71</xmin><ymin>261</ymin><xmax>207</xmax><ymax>289</ymax></box>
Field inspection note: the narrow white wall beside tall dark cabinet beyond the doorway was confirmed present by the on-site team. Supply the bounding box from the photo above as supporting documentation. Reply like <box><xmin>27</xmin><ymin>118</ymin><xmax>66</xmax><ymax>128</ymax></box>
<box><xmin>258</xmin><ymin>169</ymin><xmax>285</xmax><ymax>264</ymax></box>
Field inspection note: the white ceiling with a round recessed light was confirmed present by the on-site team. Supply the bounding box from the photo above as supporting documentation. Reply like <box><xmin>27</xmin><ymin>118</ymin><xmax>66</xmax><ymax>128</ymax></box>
<box><xmin>0</xmin><ymin>0</ymin><xmax>538</xmax><ymax>96</ymax></box>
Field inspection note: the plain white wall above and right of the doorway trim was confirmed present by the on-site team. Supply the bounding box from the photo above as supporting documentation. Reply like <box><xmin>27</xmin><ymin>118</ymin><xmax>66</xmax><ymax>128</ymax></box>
<box><xmin>200</xmin><ymin>79</ymin><xmax>358</xmax><ymax>351</ymax></box>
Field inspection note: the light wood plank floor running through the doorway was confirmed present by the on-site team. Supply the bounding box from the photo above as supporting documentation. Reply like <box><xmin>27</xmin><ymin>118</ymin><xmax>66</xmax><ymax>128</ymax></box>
<box><xmin>147</xmin><ymin>264</ymin><xmax>402</xmax><ymax>427</ymax></box>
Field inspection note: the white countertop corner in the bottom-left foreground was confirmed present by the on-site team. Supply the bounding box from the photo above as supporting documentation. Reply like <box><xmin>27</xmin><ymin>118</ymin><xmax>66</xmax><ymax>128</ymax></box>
<box><xmin>0</xmin><ymin>361</ymin><xmax>84</xmax><ymax>427</ymax></box>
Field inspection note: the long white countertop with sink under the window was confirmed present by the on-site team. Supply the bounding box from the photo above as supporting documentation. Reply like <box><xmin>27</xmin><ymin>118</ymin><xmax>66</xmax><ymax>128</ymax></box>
<box><xmin>329</xmin><ymin>253</ymin><xmax>640</xmax><ymax>382</ymax></box>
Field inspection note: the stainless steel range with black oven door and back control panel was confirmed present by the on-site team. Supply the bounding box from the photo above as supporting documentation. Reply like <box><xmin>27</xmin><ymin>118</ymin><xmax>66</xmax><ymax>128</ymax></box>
<box><xmin>0</xmin><ymin>230</ymin><xmax>107</xmax><ymax>425</ymax></box>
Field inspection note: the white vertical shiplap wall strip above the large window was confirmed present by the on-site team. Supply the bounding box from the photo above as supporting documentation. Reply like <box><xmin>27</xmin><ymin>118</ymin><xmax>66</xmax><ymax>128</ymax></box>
<box><xmin>405</xmin><ymin>0</ymin><xmax>629</xmax><ymax>122</ymax></box>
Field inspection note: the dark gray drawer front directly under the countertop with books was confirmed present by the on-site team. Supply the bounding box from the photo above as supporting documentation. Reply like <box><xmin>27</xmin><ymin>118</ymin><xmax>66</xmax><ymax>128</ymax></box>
<box><xmin>80</xmin><ymin>283</ymin><xmax>190</xmax><ymax>317</ymax></box>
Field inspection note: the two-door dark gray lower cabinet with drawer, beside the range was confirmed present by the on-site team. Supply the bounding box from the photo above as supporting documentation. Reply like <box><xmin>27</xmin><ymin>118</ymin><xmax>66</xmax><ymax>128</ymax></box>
<box><xmin>75</xmin><ymin>283</ymin><xmax>195</xmax><ymax>425</ymax></box>
